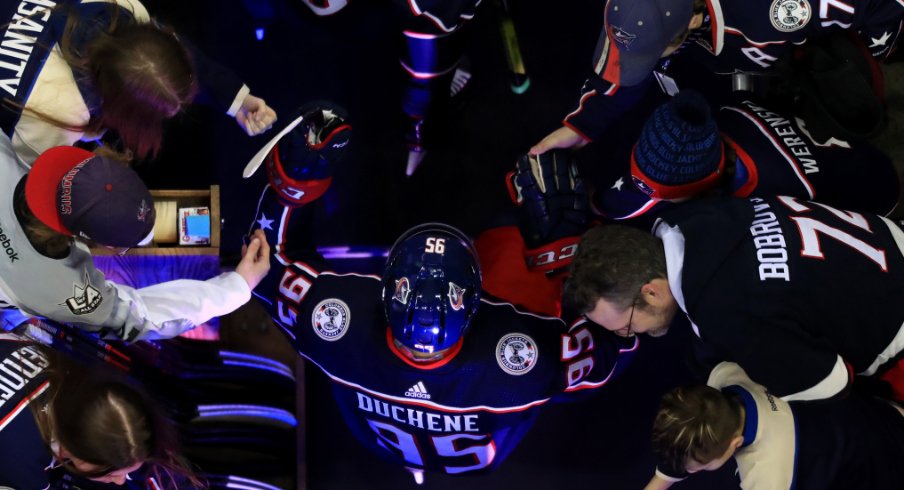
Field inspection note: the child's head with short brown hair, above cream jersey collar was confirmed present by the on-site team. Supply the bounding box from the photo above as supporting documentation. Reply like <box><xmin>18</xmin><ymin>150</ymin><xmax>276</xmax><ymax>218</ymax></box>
<box><xmin>653</xmin><ymin>385</ymin><xmax>744</xmax><ymax>473</ymax></box>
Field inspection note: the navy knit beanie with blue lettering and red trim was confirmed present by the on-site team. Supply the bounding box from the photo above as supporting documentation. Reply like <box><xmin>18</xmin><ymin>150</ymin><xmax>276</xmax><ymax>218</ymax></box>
<box><xmin>631</xmin><ymin>90</ymin><xmax>725</xmax><ymax>199</ymax></box>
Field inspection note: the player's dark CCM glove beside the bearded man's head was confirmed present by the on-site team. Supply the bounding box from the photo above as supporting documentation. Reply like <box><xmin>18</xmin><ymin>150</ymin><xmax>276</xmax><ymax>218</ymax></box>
<box><xmin>506</xmin><ymin>150</ymin><xmax>589</xmax><ymax>274</ymax></box>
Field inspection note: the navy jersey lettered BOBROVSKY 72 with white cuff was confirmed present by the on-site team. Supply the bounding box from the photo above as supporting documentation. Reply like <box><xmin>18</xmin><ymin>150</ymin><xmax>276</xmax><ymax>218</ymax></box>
<box><xmin>654</xmin><ymin>197</ymin><xmax>904</xmax><ymax>401</ymax></box>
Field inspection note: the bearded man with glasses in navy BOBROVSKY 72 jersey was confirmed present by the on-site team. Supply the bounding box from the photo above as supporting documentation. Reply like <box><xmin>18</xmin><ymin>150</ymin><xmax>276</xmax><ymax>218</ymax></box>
<box><xmin>564</xmin><ymin>197</ymin><xmax>904</xmax><ymax>401</ymax></box>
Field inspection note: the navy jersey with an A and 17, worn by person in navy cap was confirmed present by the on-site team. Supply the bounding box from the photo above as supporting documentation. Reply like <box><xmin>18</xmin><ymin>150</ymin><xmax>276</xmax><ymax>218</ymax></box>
<box><xmin>564</xmin><ymin>0</ymin><xmax>904</xmax><ymax>140</ymax></box>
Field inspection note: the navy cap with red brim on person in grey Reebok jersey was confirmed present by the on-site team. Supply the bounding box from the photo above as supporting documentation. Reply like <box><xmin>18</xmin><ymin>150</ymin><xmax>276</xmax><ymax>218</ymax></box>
<box><xmin>25</xmin><ymin>146</ymin><xmax>156</xmax><ymax>247</ymax></box>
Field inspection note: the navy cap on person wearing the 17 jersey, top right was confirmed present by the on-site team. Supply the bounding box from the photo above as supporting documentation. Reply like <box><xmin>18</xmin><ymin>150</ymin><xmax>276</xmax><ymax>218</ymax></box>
<box><xmin>603</xmin><ymin>0</ymin><xmax>694</xmax><ymax>87</ymax></box>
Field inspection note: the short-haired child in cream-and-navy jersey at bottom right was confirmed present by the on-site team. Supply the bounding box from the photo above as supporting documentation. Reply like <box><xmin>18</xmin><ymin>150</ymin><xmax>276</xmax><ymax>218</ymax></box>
<box><xmin>646</xmin><ymin>362</ymin><xmax>904</xmax><ymax>490</ymax></box>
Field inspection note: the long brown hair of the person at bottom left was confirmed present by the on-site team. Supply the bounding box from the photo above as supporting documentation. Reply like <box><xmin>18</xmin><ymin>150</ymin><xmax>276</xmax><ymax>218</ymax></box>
<box><xmin>32</xmin><ymin>353</ymin><xmax>204</xmax><ymax>489</ymax></box>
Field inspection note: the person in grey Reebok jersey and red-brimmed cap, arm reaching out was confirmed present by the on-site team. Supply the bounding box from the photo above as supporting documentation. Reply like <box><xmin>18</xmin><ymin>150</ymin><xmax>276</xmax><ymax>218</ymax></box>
<box><xmin>0</xmin><ymin>135</ymin><xmax>269</xmax><ymax>341</ymax></box>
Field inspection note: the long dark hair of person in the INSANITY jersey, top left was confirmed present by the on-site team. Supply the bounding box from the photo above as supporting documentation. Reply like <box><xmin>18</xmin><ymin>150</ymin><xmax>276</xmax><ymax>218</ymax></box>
<box><xmin>4</xmin><ymin>4</ymin><xmax>198</xmax><ymax>159</ymax></box>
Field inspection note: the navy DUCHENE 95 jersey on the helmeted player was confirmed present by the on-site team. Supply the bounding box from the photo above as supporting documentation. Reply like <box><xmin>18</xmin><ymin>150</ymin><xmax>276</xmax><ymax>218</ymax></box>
<box><xmin>255</xmin><ymin>185</ymin><xmax>637</xmax><ymax>474</ymax></box>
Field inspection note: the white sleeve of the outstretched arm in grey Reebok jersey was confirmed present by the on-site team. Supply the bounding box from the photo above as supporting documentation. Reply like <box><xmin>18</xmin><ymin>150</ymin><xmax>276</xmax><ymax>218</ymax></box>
<box><xmin>103</xmin><ymin>272</ymin><xmax>251</xmax><ymax>342</ymax></box>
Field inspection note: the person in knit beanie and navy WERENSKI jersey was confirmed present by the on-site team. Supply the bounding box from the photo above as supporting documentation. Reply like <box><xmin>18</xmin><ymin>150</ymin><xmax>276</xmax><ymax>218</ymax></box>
<box><xmin>593</xmin><ymin>90</ymin><xmax>901</xmax><ymax>220</ymax></box>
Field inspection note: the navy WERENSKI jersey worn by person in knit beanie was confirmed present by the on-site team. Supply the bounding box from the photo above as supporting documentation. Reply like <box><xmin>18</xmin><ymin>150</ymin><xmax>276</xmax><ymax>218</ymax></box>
<box><xmin>593</xmin><ymin>94</ymin><xmax>901</xmax><ymax>220</ymax></box>
